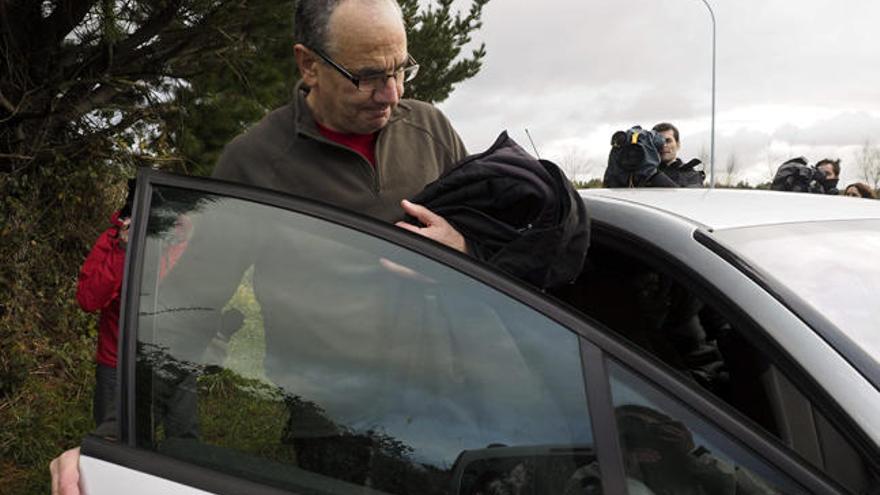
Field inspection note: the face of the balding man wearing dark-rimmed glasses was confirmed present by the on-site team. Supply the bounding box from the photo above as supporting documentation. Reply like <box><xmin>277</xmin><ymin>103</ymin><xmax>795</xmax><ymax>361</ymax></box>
<box><xmin>297</xmin><ymin>0</ymin><xmax>407</xmax><ymax>134</ymax></box>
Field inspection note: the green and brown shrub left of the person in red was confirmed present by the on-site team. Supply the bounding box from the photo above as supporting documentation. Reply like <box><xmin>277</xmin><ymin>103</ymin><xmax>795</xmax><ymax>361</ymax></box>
<box><xmin>0</xmin><ymin>157</ymin><xmax>126</xmax><ymax>495</ymax></box>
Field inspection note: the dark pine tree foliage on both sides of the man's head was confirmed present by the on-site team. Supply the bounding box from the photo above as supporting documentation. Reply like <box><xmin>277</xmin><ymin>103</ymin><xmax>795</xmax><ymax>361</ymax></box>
<box><xmin>0</xmin><ymin>0</ymin><xmax>488</xmax><ymax>172</ymax></box>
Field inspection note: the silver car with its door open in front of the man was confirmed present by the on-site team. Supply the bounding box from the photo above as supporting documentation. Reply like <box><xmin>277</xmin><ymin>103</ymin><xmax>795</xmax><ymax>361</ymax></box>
<box><xmin>80</xmin><ymin>171</ymin><xmax>880</xmax><ymax>495</ymax></box>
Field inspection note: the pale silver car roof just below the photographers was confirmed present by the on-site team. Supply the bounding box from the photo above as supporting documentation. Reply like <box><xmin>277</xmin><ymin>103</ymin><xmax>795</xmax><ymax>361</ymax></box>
<box><xmin>580</xmin><ymin>188</ymin><xmax>880</xmax><ymax>230</ymax></box>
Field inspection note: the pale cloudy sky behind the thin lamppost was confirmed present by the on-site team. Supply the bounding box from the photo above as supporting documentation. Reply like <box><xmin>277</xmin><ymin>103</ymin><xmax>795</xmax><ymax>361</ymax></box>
<box><xmin>440</xmin><ymin>0</ymin><xmax>880</xmax><ymax>184</ymax></box>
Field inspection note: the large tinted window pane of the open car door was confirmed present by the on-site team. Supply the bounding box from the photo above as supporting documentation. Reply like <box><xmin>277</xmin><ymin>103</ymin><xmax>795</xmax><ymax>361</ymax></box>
<box><xmin>136</xmin><ymin>188</ymin><xmax>599</xmax><ymax>494</ymax></box>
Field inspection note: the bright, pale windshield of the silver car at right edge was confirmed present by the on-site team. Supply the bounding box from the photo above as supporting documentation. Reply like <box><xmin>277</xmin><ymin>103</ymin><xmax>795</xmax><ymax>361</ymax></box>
<box><xmin>715</xmin><ymin>220</ymin><xmax>880</xmax><ymax>372</ymax></box>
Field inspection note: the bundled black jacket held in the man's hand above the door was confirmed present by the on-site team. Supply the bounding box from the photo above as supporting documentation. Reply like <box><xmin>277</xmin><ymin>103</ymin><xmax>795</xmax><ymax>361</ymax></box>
<box><xmin>410</xmin><ymin>132</ymin><xmax>590</xmax><ymax>289</ymax></box>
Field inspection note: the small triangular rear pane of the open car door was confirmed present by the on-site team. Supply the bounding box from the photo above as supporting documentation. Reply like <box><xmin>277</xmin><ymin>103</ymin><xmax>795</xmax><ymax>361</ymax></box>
<box><xmin>609</xmin><ymin>362</ymin><xmax>806</xmax><ymax>494</ymax></box>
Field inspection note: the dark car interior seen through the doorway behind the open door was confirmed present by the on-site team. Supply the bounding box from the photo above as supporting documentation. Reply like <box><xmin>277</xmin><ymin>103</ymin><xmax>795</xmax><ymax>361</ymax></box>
<box><xmin>556</xmin><ymin>239</ymin><xmax>880</xmax><ymax>493</ymax></box>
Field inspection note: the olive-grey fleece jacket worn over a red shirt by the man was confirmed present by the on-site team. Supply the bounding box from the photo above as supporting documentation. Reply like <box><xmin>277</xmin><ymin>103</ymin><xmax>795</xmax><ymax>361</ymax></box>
<box><xmin>213</xmin><ymin>84</ymin><xmax>467</xmax><ymax>222</ymax></box>
